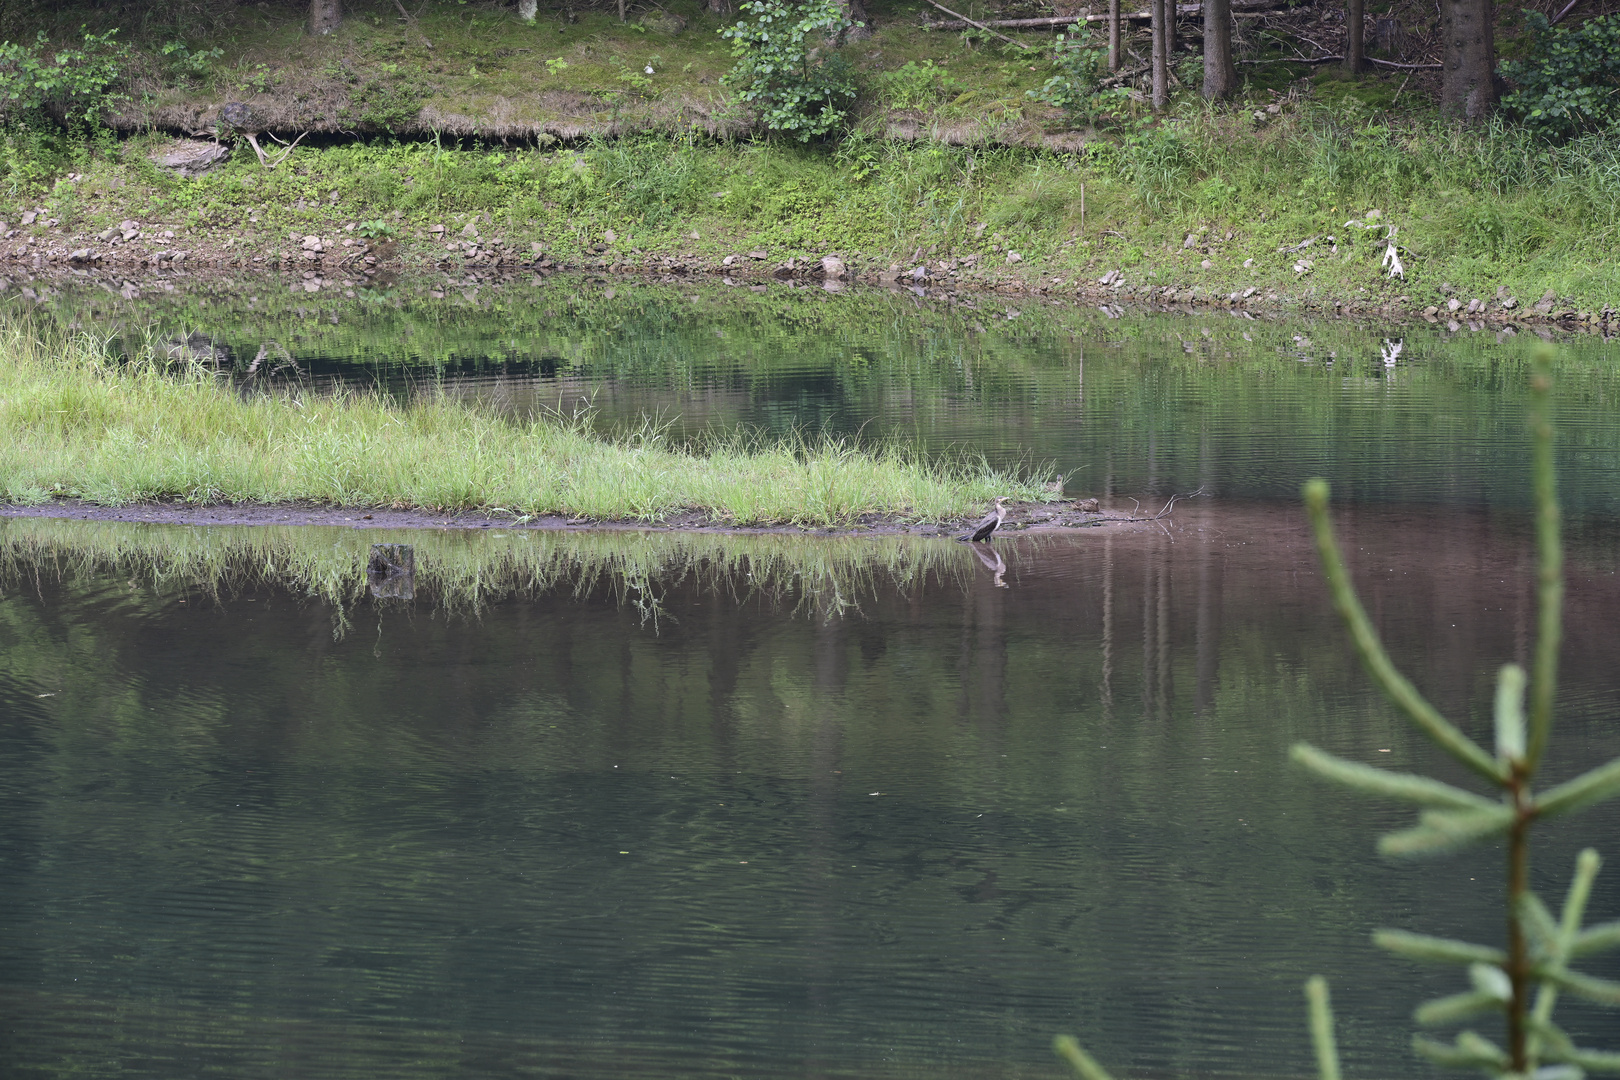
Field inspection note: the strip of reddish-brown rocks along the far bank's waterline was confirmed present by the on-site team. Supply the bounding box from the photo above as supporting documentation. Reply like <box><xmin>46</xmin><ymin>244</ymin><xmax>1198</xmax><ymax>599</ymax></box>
<box><xmin>0</xmin><ymin>202</ymin><xmax>1620</xmax><ymax>335</ymax></box>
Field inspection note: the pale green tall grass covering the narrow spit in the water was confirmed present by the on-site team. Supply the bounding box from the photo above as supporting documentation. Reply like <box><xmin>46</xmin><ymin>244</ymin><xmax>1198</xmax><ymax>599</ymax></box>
<box><xmin>0</xmin><ymin>321</ymin><xmax>1051</xmax><ymax>525</ymax></box>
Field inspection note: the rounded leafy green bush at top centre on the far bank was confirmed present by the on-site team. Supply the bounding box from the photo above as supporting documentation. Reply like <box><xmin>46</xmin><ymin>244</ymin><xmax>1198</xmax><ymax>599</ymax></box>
<box><xmin>721</xmin><ymin>0</ymin><xmax>857</xmax><ymax>142</ymax></box>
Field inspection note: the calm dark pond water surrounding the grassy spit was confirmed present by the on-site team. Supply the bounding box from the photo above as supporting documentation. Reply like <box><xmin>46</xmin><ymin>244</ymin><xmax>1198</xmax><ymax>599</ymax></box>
<box><xmin>0</xmin><ymin>282</ymin><xmax>1620</xmax><ymax>1078</ymax></box>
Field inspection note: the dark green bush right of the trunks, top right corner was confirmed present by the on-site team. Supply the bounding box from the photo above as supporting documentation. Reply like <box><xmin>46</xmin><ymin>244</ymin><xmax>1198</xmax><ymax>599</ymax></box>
<box><xmin>1502</xmin><ymin>11</ymin><xmax>1620</xmax><ymax>138</ymax></box>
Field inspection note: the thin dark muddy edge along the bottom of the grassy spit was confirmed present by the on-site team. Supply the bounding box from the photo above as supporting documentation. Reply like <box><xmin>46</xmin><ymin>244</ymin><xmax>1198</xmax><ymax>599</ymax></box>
<box><xmin>0</xmin><ymin>499</ymin><xmax>1155</xmax><ymax>538</ymax></box>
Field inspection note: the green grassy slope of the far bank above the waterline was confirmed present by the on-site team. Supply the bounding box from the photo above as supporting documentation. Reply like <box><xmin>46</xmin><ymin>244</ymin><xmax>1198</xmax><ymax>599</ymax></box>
<box><xmin>0</xmin><ymin>102</ymin><xmax>1620</xmax><ymax>321</ymax></box>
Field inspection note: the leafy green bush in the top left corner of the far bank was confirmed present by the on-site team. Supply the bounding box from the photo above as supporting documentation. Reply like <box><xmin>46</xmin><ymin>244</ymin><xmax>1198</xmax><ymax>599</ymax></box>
<box><xmin>0</xmin><ymin>29</ymin><xmax>130</xmax><ymax>126</ymax></box>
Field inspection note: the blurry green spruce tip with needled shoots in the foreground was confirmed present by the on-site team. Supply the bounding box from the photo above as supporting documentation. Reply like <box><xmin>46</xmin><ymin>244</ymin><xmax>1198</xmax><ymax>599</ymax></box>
<box><xmin>1053</xmin><ymin>347</ymin><xmax>1620</xmax><ymax>1080</ymax></box>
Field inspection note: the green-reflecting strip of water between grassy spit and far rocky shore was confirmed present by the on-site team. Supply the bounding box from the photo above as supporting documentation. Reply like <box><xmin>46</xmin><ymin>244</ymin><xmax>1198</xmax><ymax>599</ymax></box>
<box><xmin>19</xmin><ymin>279</ymin><xmax>1620</xmax><ymax>518</ymax></box>
